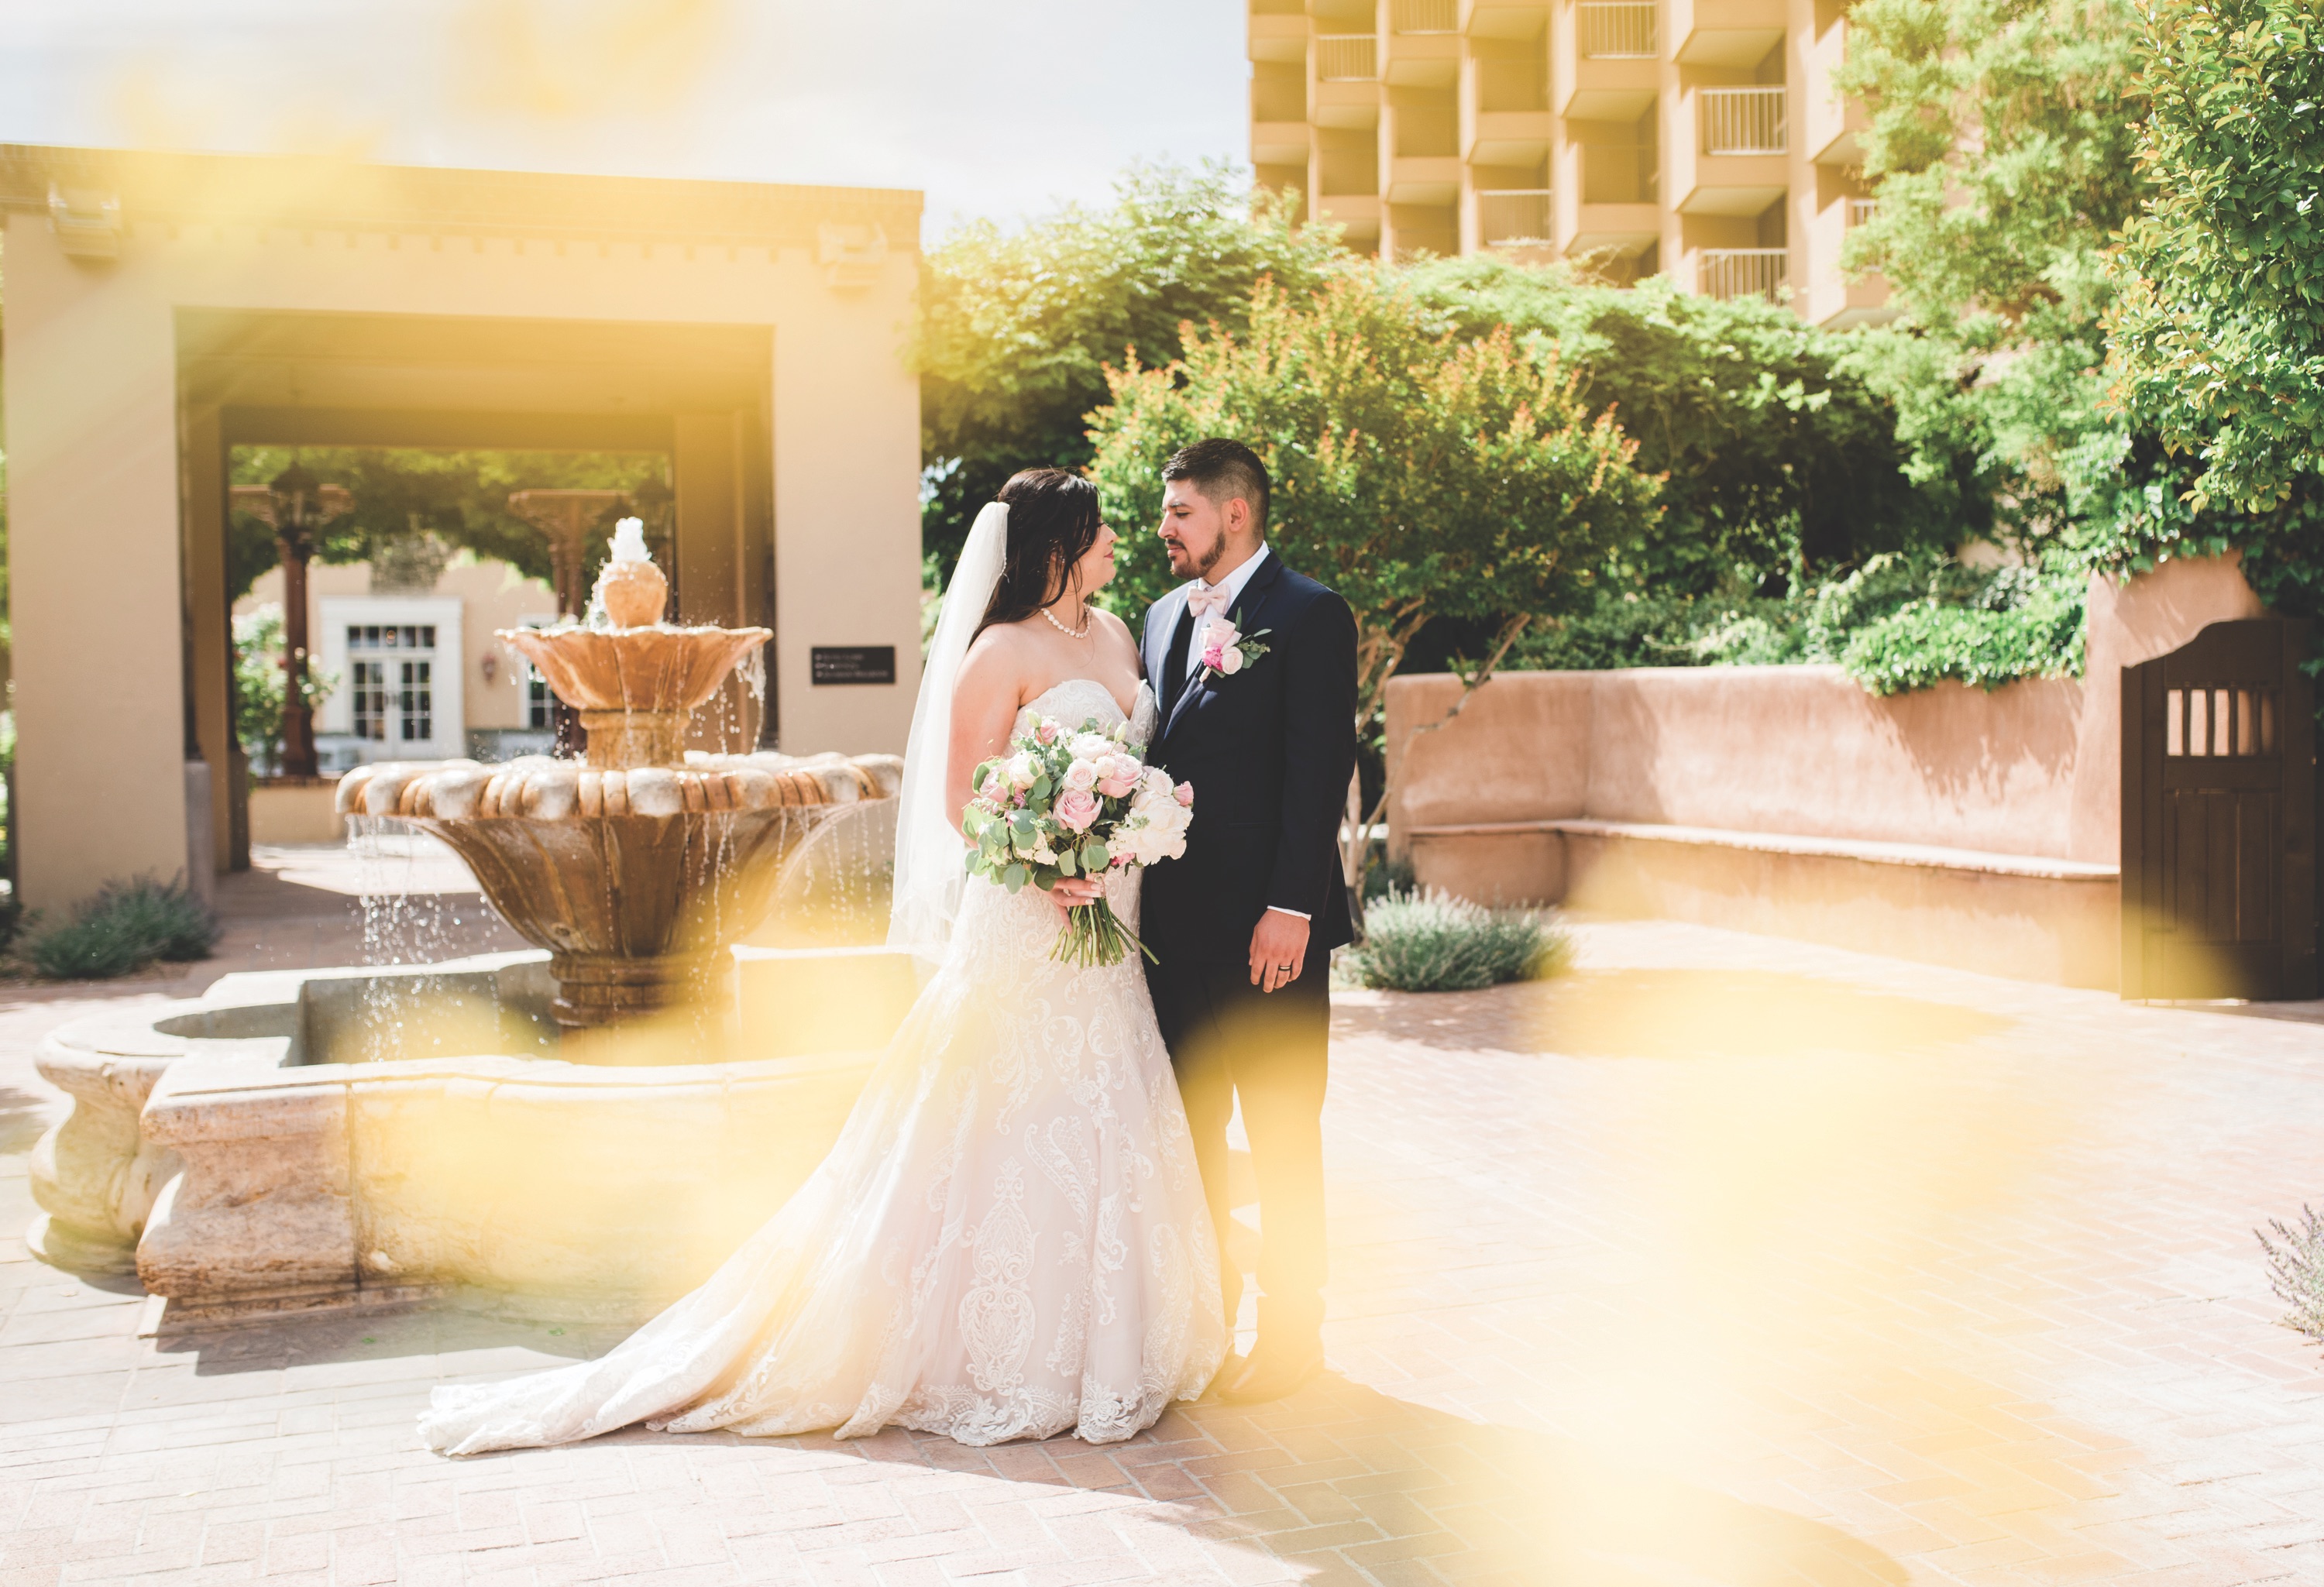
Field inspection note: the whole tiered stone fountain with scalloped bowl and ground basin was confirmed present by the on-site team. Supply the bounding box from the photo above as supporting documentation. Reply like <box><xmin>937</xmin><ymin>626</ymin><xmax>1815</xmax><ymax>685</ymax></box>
<box><xmin>28</xmin><ymin>520</ymin><xmax>911</xmax><ymax>1324</ymax></box>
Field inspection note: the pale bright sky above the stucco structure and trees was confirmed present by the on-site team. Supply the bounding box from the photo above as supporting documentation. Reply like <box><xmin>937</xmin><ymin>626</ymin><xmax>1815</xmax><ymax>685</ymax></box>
<box><xmin>0</xmin><ymin>0</ymin><xmax>1250</xmax><ymax>239</ymax></box>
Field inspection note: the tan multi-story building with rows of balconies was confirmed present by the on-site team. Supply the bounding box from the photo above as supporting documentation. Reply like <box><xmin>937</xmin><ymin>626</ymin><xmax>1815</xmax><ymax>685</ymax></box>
<box><xmin>1250</xmin><ymin>0</ymin><xmax>1887</xmax><ymax>325</ymax></box>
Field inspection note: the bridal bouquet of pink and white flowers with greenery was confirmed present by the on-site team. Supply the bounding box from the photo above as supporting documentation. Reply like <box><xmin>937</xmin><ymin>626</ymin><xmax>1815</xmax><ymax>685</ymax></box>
<box><xmin>960</xmin><ymin>716</ymin><xmax>1195</xmax><ymax>964</ymax></box>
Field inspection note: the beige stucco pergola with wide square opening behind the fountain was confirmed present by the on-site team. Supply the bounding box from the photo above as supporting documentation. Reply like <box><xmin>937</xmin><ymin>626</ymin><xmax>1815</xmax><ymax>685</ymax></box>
<box><xmin>0</xmin><ymin>146</ymin><xmax>920</xmax><ymax>909</ymax></box>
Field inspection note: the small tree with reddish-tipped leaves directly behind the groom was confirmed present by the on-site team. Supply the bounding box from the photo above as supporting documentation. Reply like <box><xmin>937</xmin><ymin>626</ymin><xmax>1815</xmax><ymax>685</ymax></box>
<box><xmin>1090</xmin><ymin>272</ymin><xmax>1659</xmax><ymax>895</ymax></box>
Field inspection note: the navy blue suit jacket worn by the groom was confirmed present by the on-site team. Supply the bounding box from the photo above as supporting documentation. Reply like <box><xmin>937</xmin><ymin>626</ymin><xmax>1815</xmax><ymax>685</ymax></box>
<box><xmin>1139</xmin><ymin>553</ymin><xmax>1355</xmax><ymax>964</ymax></box>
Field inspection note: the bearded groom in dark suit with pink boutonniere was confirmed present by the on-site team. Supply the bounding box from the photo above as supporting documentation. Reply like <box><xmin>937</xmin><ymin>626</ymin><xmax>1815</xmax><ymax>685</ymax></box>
<box><xmin>1141</xmin><ymin>439</ymin><xmax>1355</xmax><ymax>1403</ymax></box>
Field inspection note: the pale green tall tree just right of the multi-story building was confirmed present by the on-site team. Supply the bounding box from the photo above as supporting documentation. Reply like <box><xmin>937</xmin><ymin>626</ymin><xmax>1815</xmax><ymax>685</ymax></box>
<box><xmin>1834</xmin><ymin>0</ymin><xmax>2152</xmax><ymax>546</ymax></box>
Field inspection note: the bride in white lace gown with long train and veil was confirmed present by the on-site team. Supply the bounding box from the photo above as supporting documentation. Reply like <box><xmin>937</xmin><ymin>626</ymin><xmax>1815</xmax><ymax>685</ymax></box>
<box><xmin>421</xmin><ymin>469</ymin><xmax>1225</xmax><ymax>1455</ymax></box>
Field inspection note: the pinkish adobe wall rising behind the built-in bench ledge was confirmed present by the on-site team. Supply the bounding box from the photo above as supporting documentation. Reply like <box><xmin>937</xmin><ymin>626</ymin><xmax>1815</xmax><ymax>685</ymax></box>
<box><xmin>1387</xmin><ymin>558</ymin><xmax>2259</xmax><ymax>862</ymax></box>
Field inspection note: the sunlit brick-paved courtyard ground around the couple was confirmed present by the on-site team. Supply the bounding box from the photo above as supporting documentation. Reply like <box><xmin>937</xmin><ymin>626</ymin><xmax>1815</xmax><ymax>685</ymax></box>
<box><xmin>0</xmin><ymin>925</ymin><xmax>2324</xmax><ymax>1587</ymax></box>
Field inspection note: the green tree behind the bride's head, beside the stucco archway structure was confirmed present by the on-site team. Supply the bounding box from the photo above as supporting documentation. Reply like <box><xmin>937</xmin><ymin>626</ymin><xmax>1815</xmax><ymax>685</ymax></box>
<box><xmin>911</xmin><ymin>165</ymin><xmax>1353</xmax><ymax>576</ymax></box>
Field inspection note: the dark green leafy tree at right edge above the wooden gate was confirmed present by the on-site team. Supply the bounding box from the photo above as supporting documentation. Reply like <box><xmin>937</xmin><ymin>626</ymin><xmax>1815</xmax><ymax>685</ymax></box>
<box><xmin>2113</xmin><ymin>0</ymin><xmax>2324</xmax><ymax>616</ymax></box>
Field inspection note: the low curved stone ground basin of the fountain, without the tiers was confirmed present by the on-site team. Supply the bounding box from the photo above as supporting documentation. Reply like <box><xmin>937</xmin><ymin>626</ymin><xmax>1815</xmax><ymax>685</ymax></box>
<box><xmin>33</xmin><ymin>948</ymin><xmax>916</xmax><ymax>1322</ymax></box>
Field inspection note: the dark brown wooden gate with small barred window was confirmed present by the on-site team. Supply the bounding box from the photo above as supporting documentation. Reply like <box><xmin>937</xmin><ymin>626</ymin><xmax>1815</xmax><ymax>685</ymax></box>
<box><xmin>2122</xmin><ymin>618</ymin><xmax>2317</xmax><ymax>999</ymax></box>
